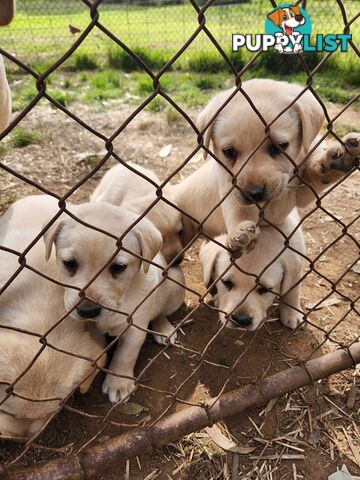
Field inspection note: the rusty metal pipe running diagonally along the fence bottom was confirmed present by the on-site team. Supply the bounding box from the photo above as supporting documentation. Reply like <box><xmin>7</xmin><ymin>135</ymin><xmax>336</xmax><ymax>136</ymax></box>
<box><xmin>0</xmin><ymin>342</ymin><xmax>360</xmax><ymax>480</ymax></box>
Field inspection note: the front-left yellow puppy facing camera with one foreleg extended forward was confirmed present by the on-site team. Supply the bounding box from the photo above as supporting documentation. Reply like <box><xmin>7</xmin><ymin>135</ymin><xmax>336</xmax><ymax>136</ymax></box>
<box><xmin>6</xmin><ymin>195</ymin><xmax>184</xmax><ymax>402</ymax></box>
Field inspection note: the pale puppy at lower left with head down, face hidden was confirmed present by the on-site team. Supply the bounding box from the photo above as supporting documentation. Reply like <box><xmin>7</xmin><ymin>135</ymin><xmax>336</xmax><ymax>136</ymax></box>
<box><xmin>0</xmin><ymin>204</ymin><xmax>106</xmax><ymax>441</ymax></box>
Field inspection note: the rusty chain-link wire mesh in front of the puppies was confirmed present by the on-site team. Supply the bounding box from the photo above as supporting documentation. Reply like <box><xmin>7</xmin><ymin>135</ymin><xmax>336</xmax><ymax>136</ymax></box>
<box><xmin>0</xmin><ymin>0</ymin><xmax>359</xmax><ymax>478</ymax></box>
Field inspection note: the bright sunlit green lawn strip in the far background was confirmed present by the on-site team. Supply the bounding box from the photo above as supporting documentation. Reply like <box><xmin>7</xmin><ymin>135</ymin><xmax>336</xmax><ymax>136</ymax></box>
<box><xmin>1</xmin><ymin>0</ymin><xmax>359</xmax><ymax>66</ymax></box>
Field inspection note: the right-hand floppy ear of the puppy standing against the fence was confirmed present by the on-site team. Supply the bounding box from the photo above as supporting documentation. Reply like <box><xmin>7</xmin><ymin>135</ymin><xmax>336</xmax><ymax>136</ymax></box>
<box><xmin>294</xmin><ymin>92</ymin><xmax>325</xmax><ymax>154</ymax></box>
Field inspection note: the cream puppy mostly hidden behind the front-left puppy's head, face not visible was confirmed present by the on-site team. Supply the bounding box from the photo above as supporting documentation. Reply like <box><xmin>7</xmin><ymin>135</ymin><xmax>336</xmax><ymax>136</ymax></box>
<box><xmin>90</xmin><ymin>162</ymin><xmax>182</xmax><ymax>263</ymax></box>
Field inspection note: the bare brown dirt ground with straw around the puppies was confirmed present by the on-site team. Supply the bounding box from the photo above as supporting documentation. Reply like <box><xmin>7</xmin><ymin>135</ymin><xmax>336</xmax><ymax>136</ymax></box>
<box><xmin>0</xmin><ymin>101</ymin><xmax>360</xmax><ymax>480</ymax></box>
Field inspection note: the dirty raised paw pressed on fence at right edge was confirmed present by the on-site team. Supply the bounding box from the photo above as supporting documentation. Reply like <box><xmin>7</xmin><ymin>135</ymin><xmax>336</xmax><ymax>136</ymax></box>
<box><xmin>321</xmin><ymin>133</ymin><xmax>360</xmax><ymax>175</ymax></box>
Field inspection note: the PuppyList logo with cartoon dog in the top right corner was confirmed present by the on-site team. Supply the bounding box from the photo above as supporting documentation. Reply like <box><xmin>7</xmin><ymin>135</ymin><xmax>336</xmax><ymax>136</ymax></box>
<box><xmin>232</xmin><ymin>3</ymin><xmax>351</xmax><ymax>54</ymax></box>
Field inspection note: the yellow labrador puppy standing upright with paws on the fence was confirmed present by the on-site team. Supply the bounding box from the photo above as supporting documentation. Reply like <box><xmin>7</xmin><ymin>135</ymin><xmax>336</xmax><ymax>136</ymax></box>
<box><xmin>173</xmin><ymin>79</ymin><xmax>360</xmax><ymax>253</ymax></box>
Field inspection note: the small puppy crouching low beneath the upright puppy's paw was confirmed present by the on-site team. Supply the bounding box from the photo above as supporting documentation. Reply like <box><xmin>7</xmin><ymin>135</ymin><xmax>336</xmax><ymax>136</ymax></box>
<box><xmin>200</xmin><ymin>209</ymin><xmax>305</xmax><ymax>330</ymax></box>
